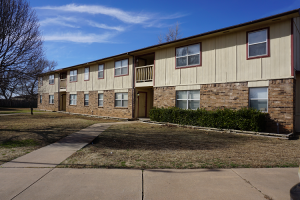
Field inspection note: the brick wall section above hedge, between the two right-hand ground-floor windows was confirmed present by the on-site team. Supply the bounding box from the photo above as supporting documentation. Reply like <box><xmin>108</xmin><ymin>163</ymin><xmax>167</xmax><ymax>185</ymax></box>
<box><xmin>200</xmin><ymin>82</ymin><xmax>249</xmax><ymax>110</ymax></box>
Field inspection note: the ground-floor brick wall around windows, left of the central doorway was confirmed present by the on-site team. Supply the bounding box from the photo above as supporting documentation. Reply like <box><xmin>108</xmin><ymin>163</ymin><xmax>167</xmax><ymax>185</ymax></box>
<box><xmin>66</xmin><ymin>89</ymin><xmax>132</xmax><ymax>118</ymax></box>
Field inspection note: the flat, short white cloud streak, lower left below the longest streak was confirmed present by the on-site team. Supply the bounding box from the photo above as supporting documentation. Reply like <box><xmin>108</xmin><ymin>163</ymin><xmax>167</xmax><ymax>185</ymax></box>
<box><xmin>44</xmin><ymin>32</ymin><xmax>114</xmax><ymax>43</ymax></box>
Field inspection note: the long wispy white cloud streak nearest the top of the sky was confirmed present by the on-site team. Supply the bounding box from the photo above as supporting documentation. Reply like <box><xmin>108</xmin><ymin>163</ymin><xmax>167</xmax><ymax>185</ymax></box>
<box><xmin>35</xmin><ymin>4</ymin><xmax>151</xmax><ymax>24</ymax></box>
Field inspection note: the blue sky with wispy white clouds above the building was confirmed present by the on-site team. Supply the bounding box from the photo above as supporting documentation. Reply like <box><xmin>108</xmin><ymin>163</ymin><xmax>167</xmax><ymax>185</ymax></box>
<box><xmin>29</xmin><ymin>0</ymin><xmax>300</xmax><ymax>69</ymax></box>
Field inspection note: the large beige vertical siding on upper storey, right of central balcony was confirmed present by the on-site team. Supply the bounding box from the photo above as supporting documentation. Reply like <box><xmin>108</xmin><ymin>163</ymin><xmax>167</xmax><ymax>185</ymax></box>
<box><xmin>155</xmin><ymin>19</ymin><xmax>292</xmax><ymax>87</ymax></box>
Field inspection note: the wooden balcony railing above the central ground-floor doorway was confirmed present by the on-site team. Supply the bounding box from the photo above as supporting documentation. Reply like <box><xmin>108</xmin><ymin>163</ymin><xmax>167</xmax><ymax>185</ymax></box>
<box><xmin>135</xmin><ymin>65</ymin><xmax>153</xmax><ymax>87</ymax></box>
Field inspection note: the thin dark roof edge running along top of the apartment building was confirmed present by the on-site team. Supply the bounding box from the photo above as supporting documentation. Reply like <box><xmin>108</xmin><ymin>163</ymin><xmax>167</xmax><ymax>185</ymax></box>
<box><xmin>42</xmin><ymin>8</ymin><xmax>300</xmax><ymax>75</ymax></box>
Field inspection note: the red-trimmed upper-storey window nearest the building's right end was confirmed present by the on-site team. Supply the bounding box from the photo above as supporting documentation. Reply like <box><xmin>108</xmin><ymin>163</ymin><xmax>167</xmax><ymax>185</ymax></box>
<box><xmin>247</xmin><ymin>29</ymin><xmax>269</xmax><ymax>58</ymax></box>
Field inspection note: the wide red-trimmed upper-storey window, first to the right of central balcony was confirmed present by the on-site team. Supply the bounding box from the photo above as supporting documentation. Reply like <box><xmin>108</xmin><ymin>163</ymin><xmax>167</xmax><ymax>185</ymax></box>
<box><xmin>176</xmin><ymin>43</ymin><xmax>200</xmax><ymax>68</ymax></box>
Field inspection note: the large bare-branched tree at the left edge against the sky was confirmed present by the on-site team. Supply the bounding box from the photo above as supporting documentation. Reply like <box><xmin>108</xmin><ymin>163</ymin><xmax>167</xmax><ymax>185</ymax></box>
<box><xmin>0</xmin><ymin>0</ymin><xmax>44</xmax><ymax>98</ymax></box>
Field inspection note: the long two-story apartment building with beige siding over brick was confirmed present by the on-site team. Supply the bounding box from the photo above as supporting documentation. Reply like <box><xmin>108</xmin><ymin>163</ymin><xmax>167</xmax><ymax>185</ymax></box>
<box><xmin>38</xmin><ymin>9</ymin><xmax>300</xmax><ymax>133</ymax></box>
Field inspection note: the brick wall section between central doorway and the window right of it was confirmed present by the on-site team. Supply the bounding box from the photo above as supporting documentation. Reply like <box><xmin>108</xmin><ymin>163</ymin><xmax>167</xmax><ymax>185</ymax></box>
<box><xmin>153</xmin><ymin>87</ymin><xmax>176</xmax><ymax>108</ymax></box>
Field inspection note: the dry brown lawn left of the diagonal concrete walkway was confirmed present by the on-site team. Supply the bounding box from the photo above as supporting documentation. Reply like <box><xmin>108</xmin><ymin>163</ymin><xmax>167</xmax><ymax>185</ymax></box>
<box><xmin>0</xmin><ymin>112</ymin><xmax>114</xmax><ymax>164</ymax></box>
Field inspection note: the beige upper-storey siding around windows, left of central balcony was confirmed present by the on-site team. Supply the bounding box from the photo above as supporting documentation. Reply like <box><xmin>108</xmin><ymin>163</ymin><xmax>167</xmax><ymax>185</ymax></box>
<box><xmin>67</xmin><ymin>57</ymin><xmax>132</xmax><ymax>92</ymax></box>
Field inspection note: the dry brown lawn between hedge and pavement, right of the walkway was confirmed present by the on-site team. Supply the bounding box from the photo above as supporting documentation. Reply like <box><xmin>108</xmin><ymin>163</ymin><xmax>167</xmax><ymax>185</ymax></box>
<box><xmin>60</xmin><ymin>123</ymin><xmax>300</xmax><ymax>169</ymax></box>
